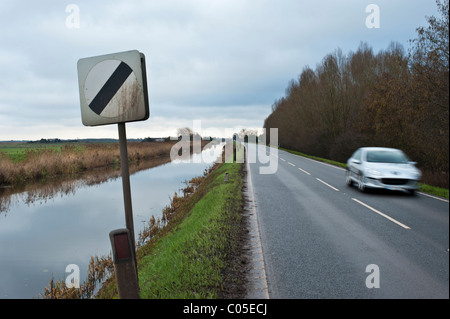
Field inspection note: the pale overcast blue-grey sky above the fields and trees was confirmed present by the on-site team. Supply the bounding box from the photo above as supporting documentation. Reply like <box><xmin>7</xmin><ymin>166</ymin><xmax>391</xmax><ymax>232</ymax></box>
<box><xmin>0</xmin><ymin>0</ymin><xmax>436</xmax><ymax>140</ymax></box>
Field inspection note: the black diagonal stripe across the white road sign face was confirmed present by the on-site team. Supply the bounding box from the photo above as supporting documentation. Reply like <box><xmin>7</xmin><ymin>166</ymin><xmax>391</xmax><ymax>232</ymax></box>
<box><xmin>89</xmin><ymin>62</ymin><xmax>133</xmax><ymax>115</ymax></box>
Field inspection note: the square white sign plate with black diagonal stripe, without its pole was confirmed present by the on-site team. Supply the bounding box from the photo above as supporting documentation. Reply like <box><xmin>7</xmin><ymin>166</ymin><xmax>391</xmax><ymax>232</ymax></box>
<box><xmin>77</xmin><ymin>50</ymin><xmax>150</xmax><ymax>126</ymax></box>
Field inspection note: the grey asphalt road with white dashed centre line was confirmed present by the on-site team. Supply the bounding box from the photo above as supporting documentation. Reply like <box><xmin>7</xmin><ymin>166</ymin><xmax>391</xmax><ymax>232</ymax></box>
<box><xmin>250</xmin><ymin>147</ymin><xmax>449</xmax><ymax>299</ymax></box>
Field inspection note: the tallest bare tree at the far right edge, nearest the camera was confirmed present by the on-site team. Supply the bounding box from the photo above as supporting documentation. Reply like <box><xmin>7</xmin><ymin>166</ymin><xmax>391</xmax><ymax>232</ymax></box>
<box><xmin>410</xmin><ymin>0</ymin><xmax>449</xmax><ymax>180</ymax></box>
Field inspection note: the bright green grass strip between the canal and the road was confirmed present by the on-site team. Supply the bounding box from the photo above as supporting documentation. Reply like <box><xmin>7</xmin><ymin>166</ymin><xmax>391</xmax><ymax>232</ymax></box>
<box><xmin>138</xmin><ymin>163</ymin><xmax>242</xmax><ymax>299</ymax></box>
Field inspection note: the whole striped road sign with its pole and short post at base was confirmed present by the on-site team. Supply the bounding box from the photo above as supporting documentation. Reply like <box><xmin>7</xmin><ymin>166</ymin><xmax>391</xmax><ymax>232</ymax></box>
<box><xmin>77</xmin><ymin>50</ymin><xmax>150</xmax><ymax>298</ymax></box>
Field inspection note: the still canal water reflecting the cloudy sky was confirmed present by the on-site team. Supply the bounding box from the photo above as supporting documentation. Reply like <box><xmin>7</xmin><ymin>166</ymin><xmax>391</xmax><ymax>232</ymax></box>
<box><xmin>0</xmin><ymin>146</ymin><xmax>221</xmax><ymax>298</ymax></box>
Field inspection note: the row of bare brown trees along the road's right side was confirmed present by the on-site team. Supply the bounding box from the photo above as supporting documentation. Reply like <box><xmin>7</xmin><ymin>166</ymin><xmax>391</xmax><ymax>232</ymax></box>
<box><xmin>264</xmin><ymin>0</ymin><xmax>449</xmax><ymax>188</ymax></box>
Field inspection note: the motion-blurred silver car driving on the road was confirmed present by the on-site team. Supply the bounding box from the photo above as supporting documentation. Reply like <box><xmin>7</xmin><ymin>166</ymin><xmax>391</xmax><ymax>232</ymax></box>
<box><xmin>345</xmin><ymin>147</ymin><xmax>422</xmax><ymax>194</ymax></box>
